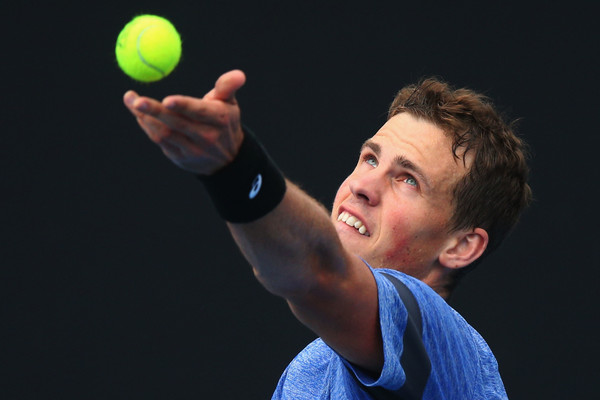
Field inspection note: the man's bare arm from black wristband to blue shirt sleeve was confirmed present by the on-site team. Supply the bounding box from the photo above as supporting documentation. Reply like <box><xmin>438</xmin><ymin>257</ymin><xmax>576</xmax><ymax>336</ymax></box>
<box><xmin>229</xmin><ymin>182</ymin><xmax>383</xmax><ymax>371</ymax></box>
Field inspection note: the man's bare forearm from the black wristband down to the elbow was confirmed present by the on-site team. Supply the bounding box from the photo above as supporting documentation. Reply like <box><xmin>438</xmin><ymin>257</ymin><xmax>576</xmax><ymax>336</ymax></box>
<box><xmin>228</xmin><ymin>181</ymin><xmax>347</xmax><ymax>298</ymax></box>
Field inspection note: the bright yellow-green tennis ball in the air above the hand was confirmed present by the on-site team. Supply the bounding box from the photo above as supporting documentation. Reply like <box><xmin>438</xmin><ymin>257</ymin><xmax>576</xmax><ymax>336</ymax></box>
<box><xmin>115</xmin><ymin>14</ymin><xmax>181</xmax><ymax>82</ymax></box>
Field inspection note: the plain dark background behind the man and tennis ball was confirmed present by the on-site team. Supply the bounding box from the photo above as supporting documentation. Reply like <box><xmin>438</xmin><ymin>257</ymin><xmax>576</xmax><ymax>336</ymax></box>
<box><xmin>0</xmin><ymin>0</ymin><xmax>600</xmax><ymax>399</ymax></box>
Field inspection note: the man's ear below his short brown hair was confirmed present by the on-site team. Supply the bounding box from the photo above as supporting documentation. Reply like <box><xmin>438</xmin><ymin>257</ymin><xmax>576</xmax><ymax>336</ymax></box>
<box><xmin>439</xmin><ymin>228</ymin><xmax>489</xmax><ymax>269</ymax></box>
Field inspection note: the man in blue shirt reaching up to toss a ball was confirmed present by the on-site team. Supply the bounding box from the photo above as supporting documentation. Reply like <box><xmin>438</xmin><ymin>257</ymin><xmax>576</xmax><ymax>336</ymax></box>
<box><xmin>124</xmin><ymin>71</ymin><xmax>530</xmax><ymax>399</ymax></box>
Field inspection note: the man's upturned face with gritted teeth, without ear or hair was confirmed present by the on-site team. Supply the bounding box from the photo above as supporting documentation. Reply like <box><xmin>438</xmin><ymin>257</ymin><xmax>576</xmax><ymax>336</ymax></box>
<box><xmin>331</xmin><ymin>113</ymin><xmax>466</xmax><ymax>278</ymax></box>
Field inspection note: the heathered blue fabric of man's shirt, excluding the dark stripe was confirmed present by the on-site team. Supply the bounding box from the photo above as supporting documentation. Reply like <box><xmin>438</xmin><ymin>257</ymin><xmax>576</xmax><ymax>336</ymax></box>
<box><xmin>273</xmin><ymin>269</ymin><xmax>507</xmax><ymax>400</ymax></box>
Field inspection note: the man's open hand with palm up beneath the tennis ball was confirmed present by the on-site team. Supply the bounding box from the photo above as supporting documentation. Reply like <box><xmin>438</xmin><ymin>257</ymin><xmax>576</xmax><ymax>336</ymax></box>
<box><xmin>123</xmin><ymin>70</ymin><xmax>246</xmax><ymax>175</ymax></box>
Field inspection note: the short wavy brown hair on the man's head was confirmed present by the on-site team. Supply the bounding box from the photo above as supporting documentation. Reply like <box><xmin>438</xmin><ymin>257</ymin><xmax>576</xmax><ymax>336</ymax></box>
<box><xmin>388</xmin><ymin>78</ymin><xmax>531</xmax><ymax>260</ymax></box>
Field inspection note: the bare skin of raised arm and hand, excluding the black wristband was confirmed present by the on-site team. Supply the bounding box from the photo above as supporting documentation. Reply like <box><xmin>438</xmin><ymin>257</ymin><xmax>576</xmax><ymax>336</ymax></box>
<box><xmin>124</xmin><ymin>71</ymin><xmax>383</xmax><ymax>372</ymax></box>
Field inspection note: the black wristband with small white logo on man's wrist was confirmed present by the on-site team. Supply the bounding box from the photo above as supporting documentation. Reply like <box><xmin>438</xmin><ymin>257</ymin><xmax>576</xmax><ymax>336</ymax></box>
<box><xmin>198</xmin><ymin>127</ymin><xmax>286</xmax><ymax>223</ymax></box>
